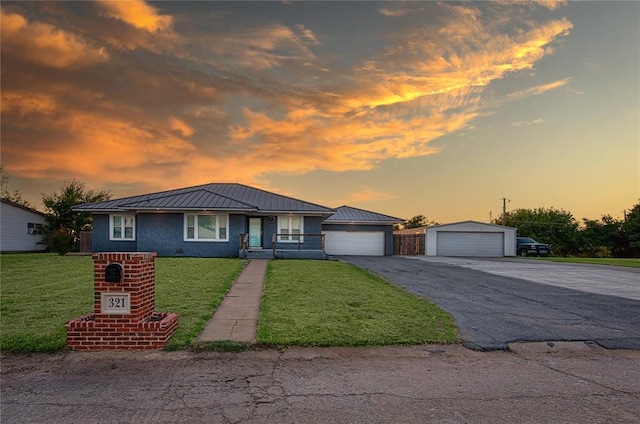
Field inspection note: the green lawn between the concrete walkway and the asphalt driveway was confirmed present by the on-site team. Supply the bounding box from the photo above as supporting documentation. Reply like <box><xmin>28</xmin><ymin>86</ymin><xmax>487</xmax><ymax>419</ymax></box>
<box><xmin>258</xmin><ymin>260</ymin><xmax>458</xmax><ymax>346</ymax></box>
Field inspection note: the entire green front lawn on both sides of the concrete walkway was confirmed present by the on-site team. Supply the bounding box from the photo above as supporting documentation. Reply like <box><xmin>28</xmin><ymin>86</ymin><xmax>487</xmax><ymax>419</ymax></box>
<box><xmin>0</xmin><ymin>254</ymin><xmax>457</xmax><ymax>352</ymax></box>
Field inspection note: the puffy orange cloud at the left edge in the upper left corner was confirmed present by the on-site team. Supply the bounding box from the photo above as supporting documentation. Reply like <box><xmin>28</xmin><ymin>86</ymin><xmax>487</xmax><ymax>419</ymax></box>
<box><xmin>0</xmin><ymin>9</ymin><xmax>109</xmax><ymax>68</ymax></box>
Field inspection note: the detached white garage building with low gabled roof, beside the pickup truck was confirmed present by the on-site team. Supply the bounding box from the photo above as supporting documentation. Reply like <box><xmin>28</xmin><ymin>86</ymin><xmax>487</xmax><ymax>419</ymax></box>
<box><xmin>425</xmin><ymin>221</ymin><xmax>516</xmax><ymax>257</ymax></box>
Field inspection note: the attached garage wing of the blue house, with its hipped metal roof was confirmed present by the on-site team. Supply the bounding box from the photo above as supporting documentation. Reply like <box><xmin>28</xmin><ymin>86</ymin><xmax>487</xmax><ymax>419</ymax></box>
<box><xmin>322</xmin><ymin>206</ymin><xmax>404</xmax><ymax>256</ymax></box>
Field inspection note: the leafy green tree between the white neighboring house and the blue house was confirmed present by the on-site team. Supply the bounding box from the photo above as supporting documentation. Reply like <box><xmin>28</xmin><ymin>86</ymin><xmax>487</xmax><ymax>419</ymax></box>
<box><xmin>42</xmin><ymin>179</ymin><xmax>111</xmax><ymax>254</ymax></box>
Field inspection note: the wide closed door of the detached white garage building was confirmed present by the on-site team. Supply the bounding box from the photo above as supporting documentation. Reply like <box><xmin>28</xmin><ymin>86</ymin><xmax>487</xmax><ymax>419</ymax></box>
<box><xmin>436</xmin><ymin>231</ymin><xmax>504</xmax><ymax>257</ymax></box>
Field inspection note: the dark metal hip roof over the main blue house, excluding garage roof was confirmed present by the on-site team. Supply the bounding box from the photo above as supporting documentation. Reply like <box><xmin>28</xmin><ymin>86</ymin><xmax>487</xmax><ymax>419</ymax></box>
<box><xmin>73</xmin><ymin>183</ymin><xmax>333</xmax><ymax>214</ymax></box>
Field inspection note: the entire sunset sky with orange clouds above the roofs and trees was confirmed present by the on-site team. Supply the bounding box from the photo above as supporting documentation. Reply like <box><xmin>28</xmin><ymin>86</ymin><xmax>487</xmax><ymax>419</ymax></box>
<box><xmin>0</xmin><ymin>1</ymin><xmax>640</xmax><ymax>223</ymax></box>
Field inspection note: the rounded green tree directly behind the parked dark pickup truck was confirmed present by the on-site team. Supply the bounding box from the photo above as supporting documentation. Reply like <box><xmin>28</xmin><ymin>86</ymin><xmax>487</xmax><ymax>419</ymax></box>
<box><xmin>494</xmin><ymin>208</ymin><xmax>579</xmax><ymax>256</ymax></box>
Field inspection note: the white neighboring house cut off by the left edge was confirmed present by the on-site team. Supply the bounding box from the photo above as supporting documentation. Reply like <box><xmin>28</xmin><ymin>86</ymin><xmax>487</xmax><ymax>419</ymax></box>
<box><xmin>0</xmin><ymin>199</ymin><xmax>46</xmax><ymax>252</ymax></box>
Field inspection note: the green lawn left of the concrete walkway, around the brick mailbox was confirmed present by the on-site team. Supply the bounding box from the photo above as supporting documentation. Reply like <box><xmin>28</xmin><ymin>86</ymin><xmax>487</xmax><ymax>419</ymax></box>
<box><xmin>0</xmin><ymin>254</ymin><xmax>244</xmax><ymax>352</ymax></box>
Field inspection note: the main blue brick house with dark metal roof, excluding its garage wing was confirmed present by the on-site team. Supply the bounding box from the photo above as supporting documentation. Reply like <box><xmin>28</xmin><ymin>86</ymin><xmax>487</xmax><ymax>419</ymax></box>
<box><xmin>73</xmin><ymin>183</ymin><xmax>334</xmax><ymax>258</ymax></box>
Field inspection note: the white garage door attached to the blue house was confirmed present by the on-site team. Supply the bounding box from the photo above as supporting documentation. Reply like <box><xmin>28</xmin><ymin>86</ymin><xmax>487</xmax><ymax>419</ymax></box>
<box><xmin>322</xmin><ymin>231</ymin><xmax>384</xmax><ymax>256</ymax></box>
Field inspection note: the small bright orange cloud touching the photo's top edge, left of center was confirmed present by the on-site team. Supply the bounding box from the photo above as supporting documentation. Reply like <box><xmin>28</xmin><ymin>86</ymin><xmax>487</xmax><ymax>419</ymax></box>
<box><xmin>99</xmin><ymin>0</ymin><xmax>173</xmax><ymax>32</ymax></box>
